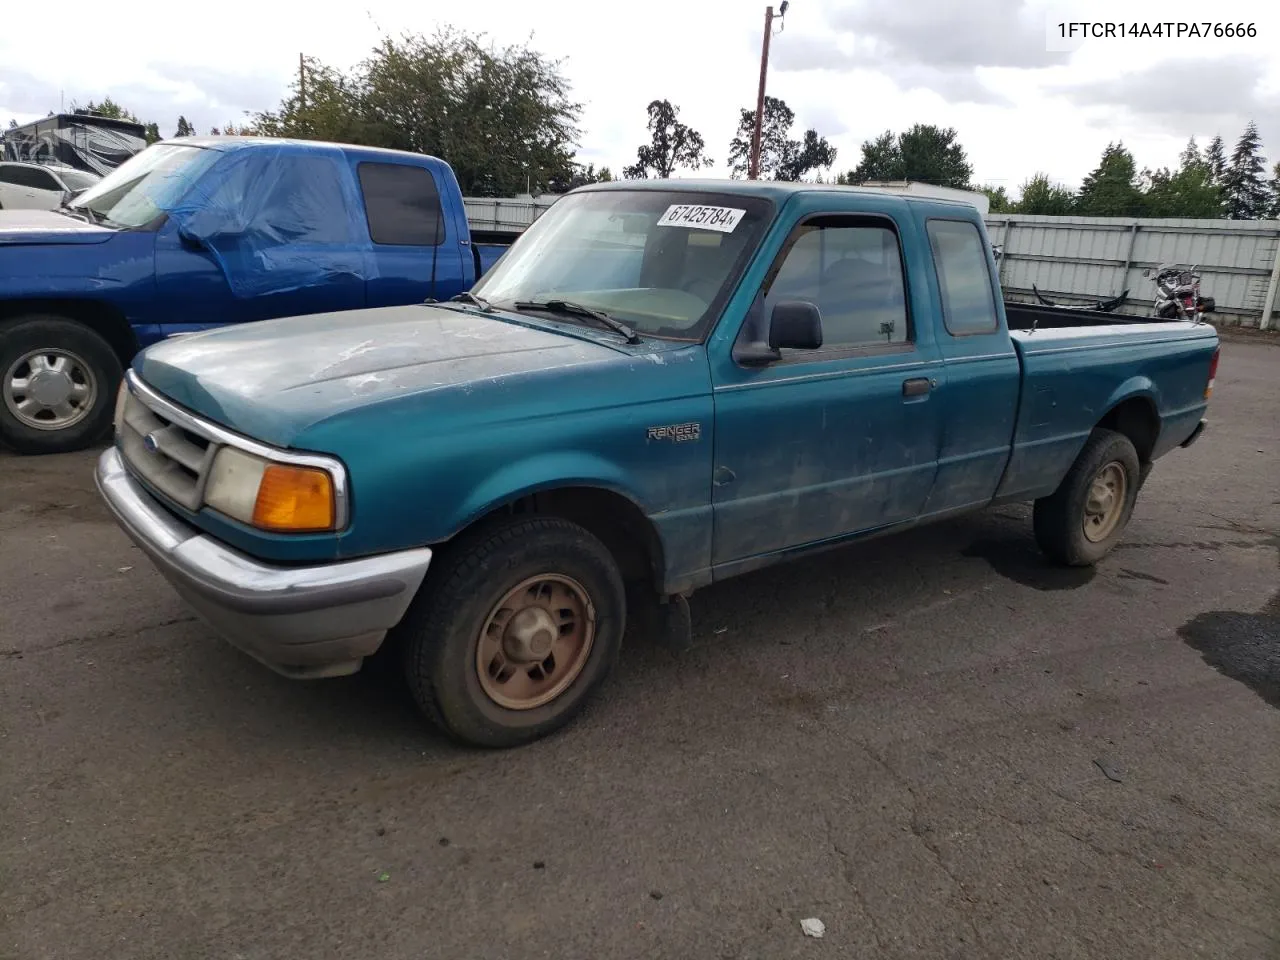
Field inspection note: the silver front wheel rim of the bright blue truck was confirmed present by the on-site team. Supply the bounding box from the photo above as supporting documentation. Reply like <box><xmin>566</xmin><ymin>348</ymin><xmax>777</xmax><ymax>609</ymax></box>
<box><xmin>0</xmin><ymin>348</ymin><xmax>99</xmax><ymax>430</ymax></box>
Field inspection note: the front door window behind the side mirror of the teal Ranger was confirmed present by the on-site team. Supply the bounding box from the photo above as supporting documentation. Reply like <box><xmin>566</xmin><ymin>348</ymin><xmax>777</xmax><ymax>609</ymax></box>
<box><xmin>764</xmin><ymin>218</ymin><xmax>911</xmax><ymax>349</ymax></box>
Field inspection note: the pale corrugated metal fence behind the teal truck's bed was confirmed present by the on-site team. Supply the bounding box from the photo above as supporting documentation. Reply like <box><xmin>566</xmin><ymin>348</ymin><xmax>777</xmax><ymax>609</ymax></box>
<box><xmin>986</xmin><ymin>214</ymin><xmax>1280</xmax><ymax>329</ymax></box>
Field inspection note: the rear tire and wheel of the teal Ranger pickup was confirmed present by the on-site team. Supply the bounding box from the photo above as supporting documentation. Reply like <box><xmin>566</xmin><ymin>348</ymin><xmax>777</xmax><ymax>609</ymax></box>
<box><xmin>1032</xmin><ymin>428</ymin><xmax>1142</xmax><ymax>567</ymax></box>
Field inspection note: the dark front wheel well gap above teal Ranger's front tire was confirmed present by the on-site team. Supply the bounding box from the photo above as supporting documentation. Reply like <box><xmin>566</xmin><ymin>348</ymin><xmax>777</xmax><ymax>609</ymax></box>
<box><xmin>472</xmin><ymin>486</ymin><xmax>664</xmax><ymax>590</ymax></box>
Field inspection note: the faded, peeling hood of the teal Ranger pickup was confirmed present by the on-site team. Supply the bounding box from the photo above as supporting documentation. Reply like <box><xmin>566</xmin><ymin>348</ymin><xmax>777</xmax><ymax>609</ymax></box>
<box><xmin>134</xmin><ymin>305</ymin><xmax>650</xmax><ymax>447</ymax></box>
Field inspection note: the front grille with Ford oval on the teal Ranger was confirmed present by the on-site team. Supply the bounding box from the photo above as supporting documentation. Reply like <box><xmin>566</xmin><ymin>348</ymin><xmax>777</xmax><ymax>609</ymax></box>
<box><xmin>116</xmin><ymin>378</ymin><xmax>218</xmax><ymax>512</ymax></box>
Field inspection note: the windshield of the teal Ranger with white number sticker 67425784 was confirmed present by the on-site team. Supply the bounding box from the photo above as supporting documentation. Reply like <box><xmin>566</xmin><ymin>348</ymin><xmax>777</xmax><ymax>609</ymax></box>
<box><xmin>472</xmin><ymin>189</ymin><xmax>772</xmax><ymax>340</ymax></box>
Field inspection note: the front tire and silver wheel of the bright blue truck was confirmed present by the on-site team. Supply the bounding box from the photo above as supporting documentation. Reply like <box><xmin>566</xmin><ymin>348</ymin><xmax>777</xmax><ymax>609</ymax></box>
<box><xmin>0</xmin><ymin>314</ymin><xmax>124</xmax><ymax>453</ymax></box>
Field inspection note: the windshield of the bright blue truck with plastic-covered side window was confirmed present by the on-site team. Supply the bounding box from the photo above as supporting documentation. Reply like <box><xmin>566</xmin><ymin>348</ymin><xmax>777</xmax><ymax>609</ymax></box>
<box><xmin>67</xmin><ymin>143</ymin><xmax>219</xmax><ymax>228</ymax></box>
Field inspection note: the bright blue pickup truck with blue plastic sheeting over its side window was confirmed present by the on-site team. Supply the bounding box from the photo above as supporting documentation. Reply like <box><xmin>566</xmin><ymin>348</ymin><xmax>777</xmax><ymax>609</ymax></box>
<box><xmin>0</xmin><ymin>137</ymin><xmax>506</xmax><ymax>453</ymax></box>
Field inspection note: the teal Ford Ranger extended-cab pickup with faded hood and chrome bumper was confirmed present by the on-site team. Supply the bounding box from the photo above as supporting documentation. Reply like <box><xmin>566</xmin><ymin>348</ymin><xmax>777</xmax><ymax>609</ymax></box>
<box><xmin>97</xmin><ymin>180</ymin><xmax>1219</xmax><ymax>746</ymax></box>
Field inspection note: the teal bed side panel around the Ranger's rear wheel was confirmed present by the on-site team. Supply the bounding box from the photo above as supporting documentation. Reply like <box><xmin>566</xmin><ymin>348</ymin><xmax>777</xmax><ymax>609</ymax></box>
<box><xmin>997</xmin><ymin>323</ymin><xmax>1217</xmax><ymax>500</ymax></box>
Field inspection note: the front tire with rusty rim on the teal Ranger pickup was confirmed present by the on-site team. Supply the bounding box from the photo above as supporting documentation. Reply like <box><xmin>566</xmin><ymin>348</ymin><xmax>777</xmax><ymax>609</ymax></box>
<box><xmin>397</xmin><ymin>517</ymin><xmax>626</xmax><ymax>748</ymax></box>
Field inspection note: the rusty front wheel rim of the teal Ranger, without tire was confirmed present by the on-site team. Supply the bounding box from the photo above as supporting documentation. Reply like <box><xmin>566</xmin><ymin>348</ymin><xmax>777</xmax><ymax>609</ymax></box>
<box><xmin>476</xmin><ymin>573</ymin><xmax>595</xmax><ymax>710</ymax></box>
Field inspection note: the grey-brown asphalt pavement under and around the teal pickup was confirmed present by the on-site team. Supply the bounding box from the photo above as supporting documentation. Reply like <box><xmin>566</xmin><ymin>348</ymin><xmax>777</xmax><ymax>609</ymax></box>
<box><xmin>0</xmin><ymin>342</ymin><xmax>1280</xmax><ymax>960</ymax></box>
